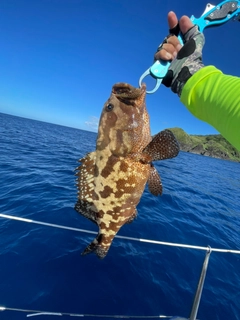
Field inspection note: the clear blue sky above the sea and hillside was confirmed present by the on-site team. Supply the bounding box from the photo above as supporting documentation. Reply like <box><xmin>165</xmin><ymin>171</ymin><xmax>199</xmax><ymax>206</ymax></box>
<box><xmin>0</xmin><ymin>0</ymin><xmax>240</xmax><ymax>134</ymax></box>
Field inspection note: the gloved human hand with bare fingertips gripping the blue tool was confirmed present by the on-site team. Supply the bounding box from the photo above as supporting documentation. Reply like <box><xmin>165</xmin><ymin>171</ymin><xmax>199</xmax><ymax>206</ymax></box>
<box><xmin>154</xmin><ymin>11</ymin><xmax>204</xmax><ymax>96</ymax></box>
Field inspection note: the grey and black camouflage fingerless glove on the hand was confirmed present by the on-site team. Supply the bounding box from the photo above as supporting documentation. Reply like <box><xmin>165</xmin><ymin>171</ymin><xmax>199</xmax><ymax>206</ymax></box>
<box><xmin>158</xmin><ymin>26</ymin><xmax>205</xmax><ymax>96</ymax></box>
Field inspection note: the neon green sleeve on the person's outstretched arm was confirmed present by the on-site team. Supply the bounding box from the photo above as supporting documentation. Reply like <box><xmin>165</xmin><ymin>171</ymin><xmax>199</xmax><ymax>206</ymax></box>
<box><xmin>180</xmin><ymin>66</ymin><xmax>240</xmax><ymax>150</ymax></box>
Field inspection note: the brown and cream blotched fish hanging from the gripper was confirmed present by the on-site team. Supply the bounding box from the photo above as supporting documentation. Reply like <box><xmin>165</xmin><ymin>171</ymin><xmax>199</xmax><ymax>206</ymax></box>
<box><xmin>75</xmin><ymin>83</ymin><xmax>179</xmax><ymax>258</ymax></box>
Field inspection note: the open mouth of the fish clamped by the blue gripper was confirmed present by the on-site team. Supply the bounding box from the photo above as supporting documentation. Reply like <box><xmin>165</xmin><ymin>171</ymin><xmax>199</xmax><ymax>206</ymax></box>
<box><xmin>112</xmin><ymin>82</ymin><xmax>146</xmax><ymax>100</ymax></box>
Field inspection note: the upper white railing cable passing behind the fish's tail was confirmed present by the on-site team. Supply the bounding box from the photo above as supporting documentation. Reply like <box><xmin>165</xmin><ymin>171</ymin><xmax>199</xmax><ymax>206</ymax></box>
<box><xmin>0</xmin><ymin>213</ymin><xmax>240</xmax><ymax>254</ymax></box>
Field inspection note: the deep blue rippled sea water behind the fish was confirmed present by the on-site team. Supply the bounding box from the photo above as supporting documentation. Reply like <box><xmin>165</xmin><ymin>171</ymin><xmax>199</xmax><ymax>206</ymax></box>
<box><xmin>0</xmin><ymin>114</ymin><xmax>240</xmax><ymax>320</ymax></box>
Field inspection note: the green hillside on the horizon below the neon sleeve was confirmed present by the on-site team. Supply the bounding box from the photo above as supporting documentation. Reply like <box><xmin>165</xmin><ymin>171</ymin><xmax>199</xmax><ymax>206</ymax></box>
<box><xmin>169</xmin><ymin>128</ymin><xmax>240</xmax><ymax>162</ymax></box>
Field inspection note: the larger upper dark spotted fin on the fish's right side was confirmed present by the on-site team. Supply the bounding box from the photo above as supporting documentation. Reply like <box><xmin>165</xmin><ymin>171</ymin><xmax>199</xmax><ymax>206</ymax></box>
<box><xmin>143</xmin><ymin>129</ymin><xmax>180</xmax><ymax>161</ymax></box>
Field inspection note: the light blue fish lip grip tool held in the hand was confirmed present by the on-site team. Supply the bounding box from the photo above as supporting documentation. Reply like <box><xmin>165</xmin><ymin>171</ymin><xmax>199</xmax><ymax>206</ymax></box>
<box><xmin>139</xmin><ymin>0</ymin><xmax>240</xmax><ymax>93</ymax></box>
